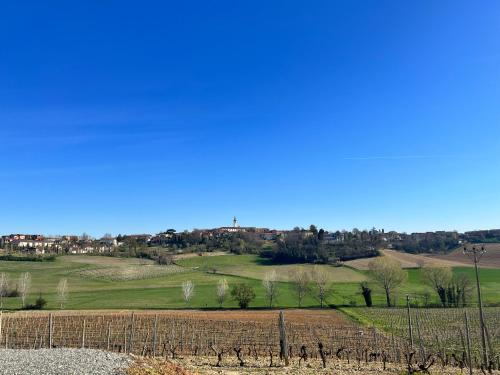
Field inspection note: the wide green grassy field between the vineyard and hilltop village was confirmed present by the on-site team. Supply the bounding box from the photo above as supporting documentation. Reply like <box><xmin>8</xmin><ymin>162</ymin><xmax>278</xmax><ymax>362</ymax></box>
<box><xmin>0</xmin><ymin>255</ymin><xmax>500</xmax><ymax>309</ymax></box>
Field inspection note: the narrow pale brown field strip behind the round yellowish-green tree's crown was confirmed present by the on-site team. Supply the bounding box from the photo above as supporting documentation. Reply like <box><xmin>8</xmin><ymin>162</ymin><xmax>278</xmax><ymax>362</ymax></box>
<box><xmin>344</xmin><ymin>249</ymin><xmax>471</xmax><ymax>270</ymax></box>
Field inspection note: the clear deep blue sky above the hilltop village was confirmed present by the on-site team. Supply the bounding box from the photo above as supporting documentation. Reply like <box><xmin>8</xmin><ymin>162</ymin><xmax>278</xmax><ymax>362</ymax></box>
<box><xmin>0</xmin><ymin>0</ymin><xmax>500</xmax><ymax>235</ymax></box>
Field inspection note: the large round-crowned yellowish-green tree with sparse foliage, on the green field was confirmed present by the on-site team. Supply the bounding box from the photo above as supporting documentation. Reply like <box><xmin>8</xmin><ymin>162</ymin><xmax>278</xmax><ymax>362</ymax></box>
<box><xmin>368</xmin><ymin>257</ymin><xmax>407</xmax><ymax>307</ymax></box>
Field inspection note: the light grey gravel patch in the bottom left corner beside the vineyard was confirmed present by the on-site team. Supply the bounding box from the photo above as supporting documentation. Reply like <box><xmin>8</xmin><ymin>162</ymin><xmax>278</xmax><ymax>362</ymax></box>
<box><xmin>0</xmin><ymin>349</ymin><xmax>133</xmax><ymax>375</ymax></box>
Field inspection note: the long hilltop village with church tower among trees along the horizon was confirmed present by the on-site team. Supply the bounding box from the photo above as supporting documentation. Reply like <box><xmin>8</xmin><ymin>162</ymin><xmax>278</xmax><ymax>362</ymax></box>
<box><xmin>0</xmin><ymin>218</ymin><xmax>500</xmax><ymax>254</ymax></box>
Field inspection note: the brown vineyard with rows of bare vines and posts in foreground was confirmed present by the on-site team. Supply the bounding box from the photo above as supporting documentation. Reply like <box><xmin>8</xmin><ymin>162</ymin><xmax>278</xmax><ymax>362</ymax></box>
<box><xmin>0</xmin><ymin>309</ymin><xmax>498</xmax><ymax>370</ymax></box>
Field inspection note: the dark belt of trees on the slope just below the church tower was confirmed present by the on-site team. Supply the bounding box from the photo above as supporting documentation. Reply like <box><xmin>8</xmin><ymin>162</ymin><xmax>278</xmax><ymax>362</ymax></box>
<box><xmin>116</xmin><ymin>225</ymin><xmax>383</xmax><ymax>264</ymax></box>
